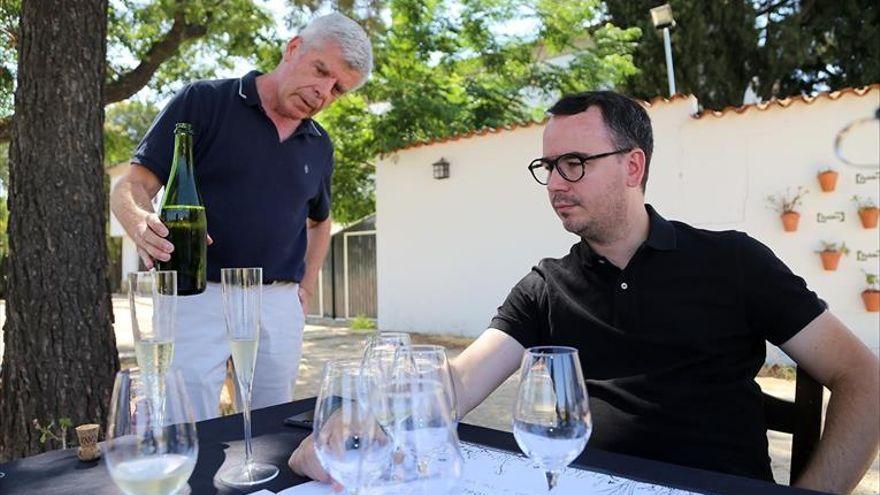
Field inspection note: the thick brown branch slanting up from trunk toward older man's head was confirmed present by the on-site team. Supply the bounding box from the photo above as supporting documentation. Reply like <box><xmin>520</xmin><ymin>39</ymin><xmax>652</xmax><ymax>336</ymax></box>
<box><xmin>104</xmin><ymin>12</ymin><xmax>208</xmax><ymax>105</ymax></box>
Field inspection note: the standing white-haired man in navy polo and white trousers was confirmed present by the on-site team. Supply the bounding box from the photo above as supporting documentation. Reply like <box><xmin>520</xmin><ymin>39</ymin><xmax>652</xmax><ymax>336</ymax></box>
<box><xmin>111</xmin><ymin>13</ymin><xmax>373</xmax><ymax>420</ymax></box>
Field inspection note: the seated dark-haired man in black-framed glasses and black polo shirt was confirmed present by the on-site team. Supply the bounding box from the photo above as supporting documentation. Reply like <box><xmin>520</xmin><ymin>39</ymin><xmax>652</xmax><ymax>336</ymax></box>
<box><xmin>290</xmin><ymin>91</ymin><xmax>880</xmax><ymax>492</ymax></box>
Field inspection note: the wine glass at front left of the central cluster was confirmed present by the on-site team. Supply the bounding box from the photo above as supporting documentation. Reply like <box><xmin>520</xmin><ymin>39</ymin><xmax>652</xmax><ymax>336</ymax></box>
<box><xmin>313</xmin><ymin>359</ymin><xmax>392</xmax><ymax>495</ymax></box>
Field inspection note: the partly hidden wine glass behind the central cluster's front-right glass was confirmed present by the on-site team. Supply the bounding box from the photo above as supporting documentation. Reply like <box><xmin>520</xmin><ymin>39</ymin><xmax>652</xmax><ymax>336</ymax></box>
<box><xmin>394</xmin><ymin>345</ymin><xmax>460</xmax><ymax>423</ymax></box>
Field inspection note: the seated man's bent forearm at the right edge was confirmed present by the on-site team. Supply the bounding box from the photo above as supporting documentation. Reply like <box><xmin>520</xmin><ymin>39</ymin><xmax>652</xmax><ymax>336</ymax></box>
<box><xmin>795</xmin><ymin>361</ymin><xmax>880</xmax><ymax>493</ymax></box>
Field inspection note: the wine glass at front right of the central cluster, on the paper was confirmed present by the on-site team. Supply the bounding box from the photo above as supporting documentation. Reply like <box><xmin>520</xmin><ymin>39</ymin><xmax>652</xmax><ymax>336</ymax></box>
<box><xmin>374</xmin><ymin>375</ymin><xmax>464</xmax><ymax>495</ymax></box>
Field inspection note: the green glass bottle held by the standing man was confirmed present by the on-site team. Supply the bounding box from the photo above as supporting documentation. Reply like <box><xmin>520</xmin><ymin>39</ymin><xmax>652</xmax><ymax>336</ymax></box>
<box><xmin>158</xmin><ymin>123</ymin><xmax>208</xmax><ymax>296</ymax></box>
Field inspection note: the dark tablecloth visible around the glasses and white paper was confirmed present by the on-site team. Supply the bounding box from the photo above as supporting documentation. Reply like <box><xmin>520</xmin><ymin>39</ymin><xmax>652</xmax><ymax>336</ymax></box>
<box><xmin>0</xmin><ymin>399</ymin><xmax>817</xmax><ymax>495</ymax></box>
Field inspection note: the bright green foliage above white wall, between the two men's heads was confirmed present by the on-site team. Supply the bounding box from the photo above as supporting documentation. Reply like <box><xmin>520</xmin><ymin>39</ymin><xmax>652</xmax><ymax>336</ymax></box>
<box><xmin>310</xmin><ymin>0</ymin><xmax>639</xmax><ymax>223</ymax></box>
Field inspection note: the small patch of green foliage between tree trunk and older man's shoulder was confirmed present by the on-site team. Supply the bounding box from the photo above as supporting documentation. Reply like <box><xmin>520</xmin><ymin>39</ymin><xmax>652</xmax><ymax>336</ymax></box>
<box><xmin>104</xmin><ymin>100</ymin><xmax>159</xmax><ymax>167</ymax></box>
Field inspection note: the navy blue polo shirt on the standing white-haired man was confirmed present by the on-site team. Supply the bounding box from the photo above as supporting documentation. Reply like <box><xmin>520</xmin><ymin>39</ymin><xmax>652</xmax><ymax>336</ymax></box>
<box><xmin>133</xmin><ymin>71</ymin><xmax>333</xmax><ymax>282</ymax></box>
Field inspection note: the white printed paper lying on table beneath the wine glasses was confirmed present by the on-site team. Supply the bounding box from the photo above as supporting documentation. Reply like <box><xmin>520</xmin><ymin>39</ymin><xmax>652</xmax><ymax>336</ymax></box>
<box><xmin>262</xmin><ymin>442</ymin><xmax>697</xmax><ymax>495</ymax></box>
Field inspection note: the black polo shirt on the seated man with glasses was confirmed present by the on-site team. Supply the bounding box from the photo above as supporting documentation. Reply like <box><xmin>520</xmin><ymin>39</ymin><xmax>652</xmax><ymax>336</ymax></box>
<box><xmin>490</xmin><ymin>206</ymin><xmax>825</xmax><ymax>481</ymax></box>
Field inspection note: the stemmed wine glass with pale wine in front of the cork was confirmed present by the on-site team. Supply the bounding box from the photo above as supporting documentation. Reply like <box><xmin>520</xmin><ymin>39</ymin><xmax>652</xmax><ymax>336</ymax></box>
<box><xmin>104</xmin><ymin>368</ymin><xmax>199</xmax><ymax>495</ymax></box>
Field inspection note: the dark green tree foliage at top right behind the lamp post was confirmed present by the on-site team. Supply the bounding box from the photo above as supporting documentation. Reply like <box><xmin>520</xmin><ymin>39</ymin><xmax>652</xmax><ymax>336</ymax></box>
<box><xmin>605</xmin><ymin>0</ymin><xmax>880</xmax><ymax>108</ymax></box>
